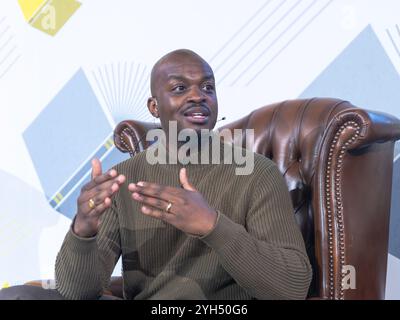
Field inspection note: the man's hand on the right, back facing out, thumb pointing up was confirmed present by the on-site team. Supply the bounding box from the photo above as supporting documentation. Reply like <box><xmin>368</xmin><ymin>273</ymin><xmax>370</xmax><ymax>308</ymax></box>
<box><xmin>128</xmin><ymin>168</ymin><xmax>217</xmax><ymax>236</ymax></box>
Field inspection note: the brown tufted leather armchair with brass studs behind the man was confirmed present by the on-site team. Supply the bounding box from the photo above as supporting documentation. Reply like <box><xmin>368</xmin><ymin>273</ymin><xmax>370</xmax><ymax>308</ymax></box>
<box><xmin>111</xmin><ymin>98</ymin><xmax>400</xmax><ymax>299</ymax></box>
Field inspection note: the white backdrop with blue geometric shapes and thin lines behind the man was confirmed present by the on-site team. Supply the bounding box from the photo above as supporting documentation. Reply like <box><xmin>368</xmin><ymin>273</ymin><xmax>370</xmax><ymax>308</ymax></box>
<box><xmin>0</xmin><ymin>0</ymin><xmax>400</xmax><ymax>299</ymax></box>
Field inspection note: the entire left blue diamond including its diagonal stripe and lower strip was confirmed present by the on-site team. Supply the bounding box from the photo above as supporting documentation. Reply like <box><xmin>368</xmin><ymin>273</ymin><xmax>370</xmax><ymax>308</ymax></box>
<box><xmin>23</xmin><ymin>70</ymin><xmax>127</xmax><ymax>217</ymax></box>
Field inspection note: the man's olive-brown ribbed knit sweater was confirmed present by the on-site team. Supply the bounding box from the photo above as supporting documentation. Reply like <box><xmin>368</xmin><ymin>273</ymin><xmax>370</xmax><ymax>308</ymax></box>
<box><xmin>55</xmin><ymin>141</ymin><xmax>311</xmax><ymax>299</ymax></box>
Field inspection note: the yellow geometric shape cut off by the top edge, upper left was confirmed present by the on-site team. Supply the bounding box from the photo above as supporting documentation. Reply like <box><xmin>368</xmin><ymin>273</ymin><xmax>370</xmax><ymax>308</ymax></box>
<box><xmin>18</xmin><ymin>0</ymin><xmax>81</xmax><ymax>36</ymax></box>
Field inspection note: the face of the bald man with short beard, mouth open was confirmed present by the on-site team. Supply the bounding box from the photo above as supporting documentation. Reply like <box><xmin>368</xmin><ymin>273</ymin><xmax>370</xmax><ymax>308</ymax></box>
<box><xmin>154</xmin><ymin>55</ymin><xmax>218</xmax><ymax>132</ymax></box>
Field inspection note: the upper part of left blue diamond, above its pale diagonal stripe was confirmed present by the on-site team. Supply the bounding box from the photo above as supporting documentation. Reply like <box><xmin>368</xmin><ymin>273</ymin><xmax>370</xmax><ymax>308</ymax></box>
<box><xmin>23</xmin><ymin>70</ymin><xmax>112</xmax><ymax>197</ymax></box>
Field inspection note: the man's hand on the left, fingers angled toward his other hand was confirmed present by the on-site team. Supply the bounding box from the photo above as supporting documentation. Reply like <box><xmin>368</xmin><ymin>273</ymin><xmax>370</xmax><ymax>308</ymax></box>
<box><xmin>73</xmin><ymin>159</ymin><xmax>126</xmax><ymax>238</ymax></box>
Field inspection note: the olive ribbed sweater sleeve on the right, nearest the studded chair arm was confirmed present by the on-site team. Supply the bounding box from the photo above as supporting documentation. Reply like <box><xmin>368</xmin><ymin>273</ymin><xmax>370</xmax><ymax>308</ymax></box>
<box><xmin>200</xmin><ymin>164</ymin><xmax>312</xmax><ymax>299</ymax></box>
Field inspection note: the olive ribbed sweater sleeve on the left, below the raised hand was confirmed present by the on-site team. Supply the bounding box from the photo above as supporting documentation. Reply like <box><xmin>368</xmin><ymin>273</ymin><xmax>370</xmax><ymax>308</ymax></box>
<box><xmin>55</xmin><ymin>201</ymin><xmax>121</xmax><ymax>299</ymax></box>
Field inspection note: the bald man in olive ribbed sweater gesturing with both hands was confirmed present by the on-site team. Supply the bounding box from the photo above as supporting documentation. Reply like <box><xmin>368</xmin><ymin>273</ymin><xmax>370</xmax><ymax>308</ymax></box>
<box><xmin>0</xmin><ymin>50</ymin><xmax>311</xmax><ymax>299</ymax></box>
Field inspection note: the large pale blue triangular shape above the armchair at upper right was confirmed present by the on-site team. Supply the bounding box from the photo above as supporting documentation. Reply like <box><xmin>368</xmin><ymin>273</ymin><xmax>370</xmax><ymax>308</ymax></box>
<box><xmin>300</xmin><ymin>25</ymin><xmax>400</xmax><ymax>116</ymax></box>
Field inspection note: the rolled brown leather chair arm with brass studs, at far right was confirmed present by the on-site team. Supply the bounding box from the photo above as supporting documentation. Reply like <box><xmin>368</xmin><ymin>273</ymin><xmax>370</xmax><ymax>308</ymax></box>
<box><xmin>312</xmin><ymin>108</ymin><xmax>400</xmax><ymax>299</ymax></box>
